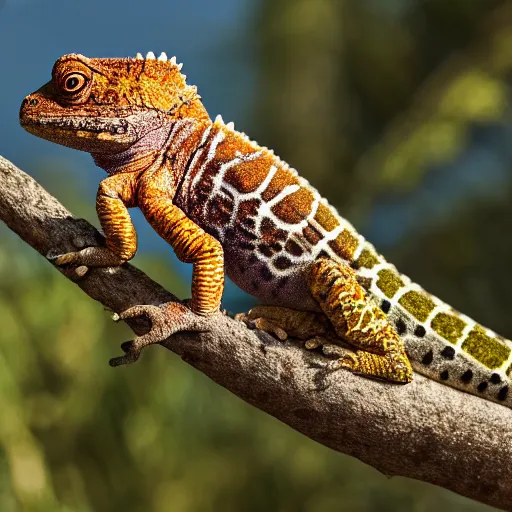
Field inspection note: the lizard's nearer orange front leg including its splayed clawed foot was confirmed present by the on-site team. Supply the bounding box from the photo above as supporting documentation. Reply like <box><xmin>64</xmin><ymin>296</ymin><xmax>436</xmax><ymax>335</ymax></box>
<box><xmin>110</xmin><ymin>176</ymin><xmax>224</xmax><ymax>366</ymax></box>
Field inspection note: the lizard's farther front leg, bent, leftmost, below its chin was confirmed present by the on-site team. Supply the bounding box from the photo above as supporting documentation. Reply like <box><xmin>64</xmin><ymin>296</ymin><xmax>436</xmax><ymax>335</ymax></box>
<box><xmin>54</xmin><ymin>174</ymin><xmax>137</xmax><ymax>267</ymax></box>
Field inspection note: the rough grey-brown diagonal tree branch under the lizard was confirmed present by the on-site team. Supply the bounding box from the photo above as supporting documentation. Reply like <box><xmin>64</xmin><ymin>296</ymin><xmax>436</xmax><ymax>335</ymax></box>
<box><xmin>0</xmin><ymin>157</ymin><xmax>512</xmax><ymax>510</ymax></box>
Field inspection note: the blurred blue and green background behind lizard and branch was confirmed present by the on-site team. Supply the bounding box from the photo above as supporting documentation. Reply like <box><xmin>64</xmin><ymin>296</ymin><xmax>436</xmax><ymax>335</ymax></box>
<box><xmin>0</xmin><ymin>0</ymin><xmax>512</xmax><ymax>512</ymax></box>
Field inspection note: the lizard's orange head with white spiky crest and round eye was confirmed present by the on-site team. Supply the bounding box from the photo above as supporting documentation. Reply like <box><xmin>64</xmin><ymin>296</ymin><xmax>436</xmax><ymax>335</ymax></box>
<box><xmin>20</xmin><ymin>52</ymin><xmax>207</xmax><ymax>153</ymax></box>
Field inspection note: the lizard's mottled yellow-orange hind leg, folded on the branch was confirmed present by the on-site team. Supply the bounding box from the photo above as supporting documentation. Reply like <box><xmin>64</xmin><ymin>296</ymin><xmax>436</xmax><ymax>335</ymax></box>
<box><xmin>308</xmin><ymin>258</ymin><xmax>412</xmax><ymax>383</ymax></box>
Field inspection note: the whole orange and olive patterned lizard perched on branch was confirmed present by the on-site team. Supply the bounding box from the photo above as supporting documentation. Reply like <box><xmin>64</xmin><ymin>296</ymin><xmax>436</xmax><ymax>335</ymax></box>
<box><xmin>20</xmin><ymin>52</ymin><xmax>512</xmax><ymax>407</ymax></box>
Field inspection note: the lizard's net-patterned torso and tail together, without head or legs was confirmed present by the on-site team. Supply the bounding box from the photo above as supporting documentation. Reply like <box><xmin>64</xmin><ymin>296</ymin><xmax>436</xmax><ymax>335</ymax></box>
<box><xmin>176</xmin><ymin>118</ymin><xmax>512</xmax><ymax>406</ymax></box>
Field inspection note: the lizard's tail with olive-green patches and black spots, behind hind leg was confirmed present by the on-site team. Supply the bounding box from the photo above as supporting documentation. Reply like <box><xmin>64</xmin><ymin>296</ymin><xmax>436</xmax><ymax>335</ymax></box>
<box><xmin>353</xmin><ymin>238</ymin><xmax>512</xmax><ymax>408</ymax></box>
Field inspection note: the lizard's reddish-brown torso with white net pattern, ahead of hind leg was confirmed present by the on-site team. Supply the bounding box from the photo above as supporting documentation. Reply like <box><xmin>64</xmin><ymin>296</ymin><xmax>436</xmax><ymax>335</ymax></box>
<box><xmin>176</xmin><ymin>119</ymin><xmax>348</xmax><ymax>310</ymax></box>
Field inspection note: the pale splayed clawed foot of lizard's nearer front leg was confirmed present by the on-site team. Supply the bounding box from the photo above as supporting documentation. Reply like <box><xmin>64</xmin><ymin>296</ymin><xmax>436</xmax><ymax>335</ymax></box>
<box><xmin>109</xmin><ymin>302</ymin><xmax>205</xmax><ymax>366</ymax></box>
